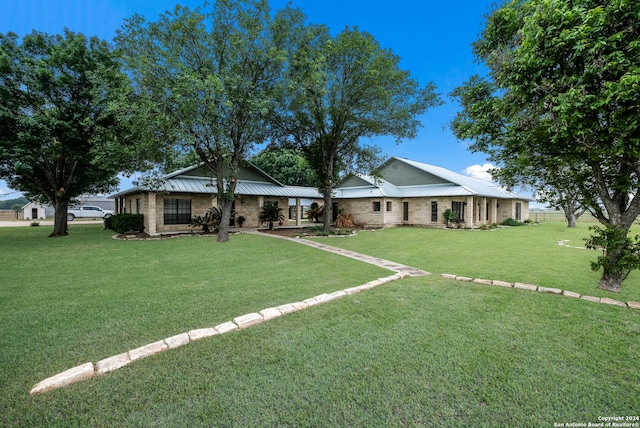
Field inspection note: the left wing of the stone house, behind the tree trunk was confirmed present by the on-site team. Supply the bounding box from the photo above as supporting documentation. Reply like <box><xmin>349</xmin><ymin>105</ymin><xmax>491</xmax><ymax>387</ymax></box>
<box><xmin>110</xmin><ymin>163</ymin><xmax>322</xmax><ymax>235</ymax></box>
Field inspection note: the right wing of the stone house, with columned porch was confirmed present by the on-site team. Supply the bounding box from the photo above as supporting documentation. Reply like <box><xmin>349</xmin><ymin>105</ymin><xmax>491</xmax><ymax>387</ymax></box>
<box><xmin>333</xmin><ymin>157</ymin><xmax>530</xmax><ymax>227</ymax></box>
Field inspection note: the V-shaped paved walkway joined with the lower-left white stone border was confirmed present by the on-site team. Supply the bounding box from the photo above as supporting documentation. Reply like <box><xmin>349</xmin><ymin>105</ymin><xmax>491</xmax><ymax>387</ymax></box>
<box><xmin>30</xmin><ymin>232</ymin><xmax>429</xmax><ymax>395</ymax></box>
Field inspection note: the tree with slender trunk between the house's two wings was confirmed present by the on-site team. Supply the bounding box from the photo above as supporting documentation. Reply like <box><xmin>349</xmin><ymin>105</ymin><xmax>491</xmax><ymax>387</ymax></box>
<box><xmin>276</xmin><ymin>25</ymin><xmax>439</xmax><ymax>229</ymax></box>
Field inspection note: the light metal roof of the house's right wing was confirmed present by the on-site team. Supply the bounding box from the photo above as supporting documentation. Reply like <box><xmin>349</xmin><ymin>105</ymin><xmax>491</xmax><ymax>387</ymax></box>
<box><xmin>335</xmin><ymin>157</ymin><xmax>530</xmax><ymax>200</ymax></box>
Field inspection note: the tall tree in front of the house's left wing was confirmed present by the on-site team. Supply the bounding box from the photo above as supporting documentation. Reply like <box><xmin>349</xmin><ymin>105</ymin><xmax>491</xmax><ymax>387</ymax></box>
<box><xmin>116</xmin><ymin>0</ymin><xmax>295</xmax><ymax>242</ymax></box>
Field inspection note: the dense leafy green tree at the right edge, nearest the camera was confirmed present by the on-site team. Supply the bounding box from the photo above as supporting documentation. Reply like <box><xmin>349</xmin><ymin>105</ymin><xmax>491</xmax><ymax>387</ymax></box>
<box><xmin>453</xmin><ymin>0</ymin><xmax>640</xmax><ymax>292</ymax></box>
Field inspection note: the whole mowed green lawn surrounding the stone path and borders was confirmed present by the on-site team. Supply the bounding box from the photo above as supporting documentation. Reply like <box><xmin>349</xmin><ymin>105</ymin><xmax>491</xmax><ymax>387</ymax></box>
<box><xmin>0</xmin><ymin>225</ymin><xmax>640</xmax><ymax>427</ymax></box>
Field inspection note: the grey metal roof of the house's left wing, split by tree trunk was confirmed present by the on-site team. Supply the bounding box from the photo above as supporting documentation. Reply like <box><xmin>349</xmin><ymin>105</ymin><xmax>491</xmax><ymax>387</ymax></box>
<box><xmin>110</xmin><ymin>162</ymin><xmax>322</xmax><ymax>198</ymax></box>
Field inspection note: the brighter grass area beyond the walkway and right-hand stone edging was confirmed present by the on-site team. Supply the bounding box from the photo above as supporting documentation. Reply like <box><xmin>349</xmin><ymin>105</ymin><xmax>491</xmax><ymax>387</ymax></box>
<box><xmin>320</xmin><ymin>222</ymin><xmax>640</xmax><ymax>302</ymax></box>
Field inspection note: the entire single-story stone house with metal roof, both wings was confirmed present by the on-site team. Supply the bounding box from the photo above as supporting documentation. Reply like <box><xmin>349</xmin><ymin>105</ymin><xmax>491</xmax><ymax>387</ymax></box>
<box><xmin>110</xmin><ymin>157</ymin><xmax>529</xmax><ymax>235</ymax></box>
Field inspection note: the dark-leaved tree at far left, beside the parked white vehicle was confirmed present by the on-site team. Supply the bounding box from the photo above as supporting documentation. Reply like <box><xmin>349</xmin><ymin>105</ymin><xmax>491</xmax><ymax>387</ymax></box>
<box><xmin>0</xmin><ymin>30</ymin><xmax>135</xmax><ymax>236</ymax></box>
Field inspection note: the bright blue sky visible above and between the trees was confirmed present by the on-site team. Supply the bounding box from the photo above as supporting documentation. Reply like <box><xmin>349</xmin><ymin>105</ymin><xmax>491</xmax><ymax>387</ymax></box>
<box><xmin>0</xmin><ymin>0</ymin><xmax>494</xmax><ymax>199</ymax></box>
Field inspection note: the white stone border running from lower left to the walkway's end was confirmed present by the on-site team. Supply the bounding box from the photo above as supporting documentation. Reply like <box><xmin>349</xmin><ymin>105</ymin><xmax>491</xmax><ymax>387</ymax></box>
<box><xmin>29</xmin><ymin>272</ymin><xmax>411</xmax><ymax>395</ymax></box>
